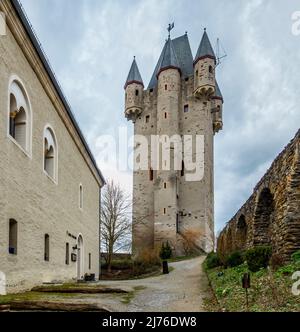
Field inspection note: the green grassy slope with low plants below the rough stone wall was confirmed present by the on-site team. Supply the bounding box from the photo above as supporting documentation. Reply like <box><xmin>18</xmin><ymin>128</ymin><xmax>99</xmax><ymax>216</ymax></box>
<box><xmin>206</xmin><ymin>263</ymin><xmax>300</xmax><ymax>312</ymax></box>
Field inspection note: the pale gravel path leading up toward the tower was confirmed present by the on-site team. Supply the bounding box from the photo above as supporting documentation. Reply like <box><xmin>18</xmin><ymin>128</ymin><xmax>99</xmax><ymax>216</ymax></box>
<box><xmin>93</xmin><ymin>257</ymin><xmax>211</xmax><ymax>312</ymax></box>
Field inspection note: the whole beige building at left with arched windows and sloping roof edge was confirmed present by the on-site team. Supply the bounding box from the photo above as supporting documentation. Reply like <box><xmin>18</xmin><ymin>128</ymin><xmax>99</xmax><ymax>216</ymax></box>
<box><xmin>0</xmin><ymin>0</ymin><xmax>105</xmax><ymax>292</ymax></box>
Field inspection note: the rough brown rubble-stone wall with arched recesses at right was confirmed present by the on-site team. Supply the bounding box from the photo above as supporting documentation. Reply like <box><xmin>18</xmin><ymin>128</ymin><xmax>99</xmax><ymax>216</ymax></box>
<box><xmin>218</xmin><ymin>131</ymin><xmax>300</xmax><ymax>261</ymax></box>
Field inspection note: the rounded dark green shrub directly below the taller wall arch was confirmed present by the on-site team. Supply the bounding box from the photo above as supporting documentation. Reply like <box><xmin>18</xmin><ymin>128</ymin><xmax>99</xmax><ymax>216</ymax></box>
<box><xmin>246</xmin><ymin>246</ymin><xmax>272</xmax><ymax>272</ymax></box>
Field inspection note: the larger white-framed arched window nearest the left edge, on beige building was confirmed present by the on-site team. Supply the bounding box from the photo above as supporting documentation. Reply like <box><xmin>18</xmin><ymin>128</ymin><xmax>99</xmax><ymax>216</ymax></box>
<box><xmin>8</xmin><ymin>79</ymin><xmax>31</xmax><ymax>153</ymax></box>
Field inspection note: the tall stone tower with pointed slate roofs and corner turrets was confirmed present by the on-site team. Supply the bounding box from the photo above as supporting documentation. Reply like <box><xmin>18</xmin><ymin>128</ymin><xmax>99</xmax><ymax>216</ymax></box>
<box><xmin>125</xmin><ymin>31</ymin><xmax>223</xmax><ymax>255</ymax></box>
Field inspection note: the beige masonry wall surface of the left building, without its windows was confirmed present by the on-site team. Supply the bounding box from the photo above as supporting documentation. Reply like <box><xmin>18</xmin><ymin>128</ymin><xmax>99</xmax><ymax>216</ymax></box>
<box><xmin>0</xmin><ymin>1</ymin><xmax>101</xmax><ymax>292</ymax></box>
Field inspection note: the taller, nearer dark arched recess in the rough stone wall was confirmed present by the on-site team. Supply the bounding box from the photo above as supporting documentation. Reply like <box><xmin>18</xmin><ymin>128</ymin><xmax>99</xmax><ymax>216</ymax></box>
<box><xmin>253</xmin><ymin>188</ymin><xmax>275</xmax><ymax>246</ymax></box>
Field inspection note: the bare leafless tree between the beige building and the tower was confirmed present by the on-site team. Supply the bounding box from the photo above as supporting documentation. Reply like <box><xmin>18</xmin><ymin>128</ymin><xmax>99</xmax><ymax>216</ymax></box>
<box><xmin>101</xmin><ymin>181</ymin><xmax>132</xmax><ymax>272</ymax></box>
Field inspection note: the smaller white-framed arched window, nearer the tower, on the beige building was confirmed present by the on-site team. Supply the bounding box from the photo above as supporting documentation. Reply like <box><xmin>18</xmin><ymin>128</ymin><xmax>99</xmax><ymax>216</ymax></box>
<box><xmin>44</xmin><ymin>127</ymin><xmax>57</xmax><ymax>181</ymax></box>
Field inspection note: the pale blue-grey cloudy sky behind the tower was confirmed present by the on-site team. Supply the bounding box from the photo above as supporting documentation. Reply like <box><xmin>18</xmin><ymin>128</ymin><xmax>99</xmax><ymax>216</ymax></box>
<box><xmin>22</xmin><ymin>0</ymin><xmax>300</xmax><ymax>230</ymax></box>
